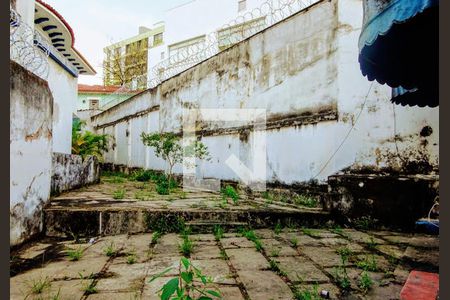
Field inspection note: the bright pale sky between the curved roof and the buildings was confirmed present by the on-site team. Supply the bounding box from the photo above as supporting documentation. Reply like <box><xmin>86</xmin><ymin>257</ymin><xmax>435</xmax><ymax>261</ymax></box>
<box><xmin>44</xmin><ymin>0</ymin><xmax>189</xmax><ymax>84</ymax></box>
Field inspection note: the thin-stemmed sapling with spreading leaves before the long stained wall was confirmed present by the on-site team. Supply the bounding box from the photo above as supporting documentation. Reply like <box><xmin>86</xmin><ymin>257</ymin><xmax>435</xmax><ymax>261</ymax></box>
<box><xmin>141</xmin><ymin>132</ymin><xmax>210</xmax><ymax>193</ymax></box>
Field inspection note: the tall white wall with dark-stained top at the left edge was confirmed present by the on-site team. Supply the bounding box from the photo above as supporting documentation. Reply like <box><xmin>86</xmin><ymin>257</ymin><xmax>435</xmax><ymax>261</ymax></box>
<box><xmin>10</xmin><ymin>62</ymin><xmax>53</xmax><ymax>246</ymax></box>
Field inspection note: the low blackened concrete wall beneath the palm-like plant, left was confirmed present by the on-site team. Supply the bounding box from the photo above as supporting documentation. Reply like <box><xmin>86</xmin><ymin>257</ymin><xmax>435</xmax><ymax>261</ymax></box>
<box><xmin>51</xmin><ymin>153</ymin><xmax>100</xmax><ymax>195</ymax></box>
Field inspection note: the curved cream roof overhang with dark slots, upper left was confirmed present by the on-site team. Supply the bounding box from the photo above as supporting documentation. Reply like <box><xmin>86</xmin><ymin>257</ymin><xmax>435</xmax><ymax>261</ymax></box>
<box><xmin>34</xmin><ymin>0</ymin><xmax>96</xmax><ymax>75</ymax></box>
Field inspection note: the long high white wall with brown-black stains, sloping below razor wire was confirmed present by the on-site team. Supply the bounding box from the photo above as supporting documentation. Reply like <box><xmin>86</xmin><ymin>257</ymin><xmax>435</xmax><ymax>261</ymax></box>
<box><xmin>92</xmin><ymin>0</ymin><xmax>439</xmax><ymax>184</ymax></box>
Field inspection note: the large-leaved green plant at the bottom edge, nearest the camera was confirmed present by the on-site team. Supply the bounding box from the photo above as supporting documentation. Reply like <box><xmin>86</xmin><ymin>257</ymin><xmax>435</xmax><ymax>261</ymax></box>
<box><xmin>149</xmin><ymin>257</ymin><xmax>222</xmax><ymax>300</ymax></box>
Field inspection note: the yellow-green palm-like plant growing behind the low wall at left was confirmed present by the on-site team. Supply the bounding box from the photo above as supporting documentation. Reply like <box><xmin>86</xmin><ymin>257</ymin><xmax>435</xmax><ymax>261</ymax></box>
<box><xmin>72</xmin><ymin>119</ymin><xmax>109</xmax><ymax>161</ymax></box>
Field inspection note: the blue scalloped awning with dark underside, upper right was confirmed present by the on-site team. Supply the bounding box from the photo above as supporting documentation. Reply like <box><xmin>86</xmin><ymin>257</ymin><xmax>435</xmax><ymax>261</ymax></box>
<box><xmin>359</xmin><ymin>0</ymin><xmax>439</xmax><ymax>107</ymax></box>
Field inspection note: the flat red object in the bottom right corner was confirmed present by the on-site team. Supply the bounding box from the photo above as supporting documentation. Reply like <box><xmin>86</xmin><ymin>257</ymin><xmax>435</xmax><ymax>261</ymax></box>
<box><xmin>400</xmin><ymin>271</ymin><xmax>439</xmax><ymax>300</ymax></box>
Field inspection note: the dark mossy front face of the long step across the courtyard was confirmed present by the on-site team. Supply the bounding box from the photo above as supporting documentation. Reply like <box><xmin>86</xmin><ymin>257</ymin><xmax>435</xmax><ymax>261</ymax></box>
<box><xmin>44</xmin><ymin>201</ymin><xmax>331</xmax><ymax>238</ymax></box>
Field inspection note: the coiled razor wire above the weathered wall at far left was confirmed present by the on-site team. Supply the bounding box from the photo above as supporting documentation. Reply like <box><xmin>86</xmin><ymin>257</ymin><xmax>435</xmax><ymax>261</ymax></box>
<box><xmin>9</xmin><ymin>7</ymin><xmax>49</xmax><ymax>80</ymax></box>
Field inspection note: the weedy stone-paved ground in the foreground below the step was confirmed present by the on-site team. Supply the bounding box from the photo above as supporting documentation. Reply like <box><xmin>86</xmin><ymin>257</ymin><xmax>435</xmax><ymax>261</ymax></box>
<box><xmin>10</xmin><ymin>229</ymin><xmax>439</xmax><ymax>300</ymax></box>
